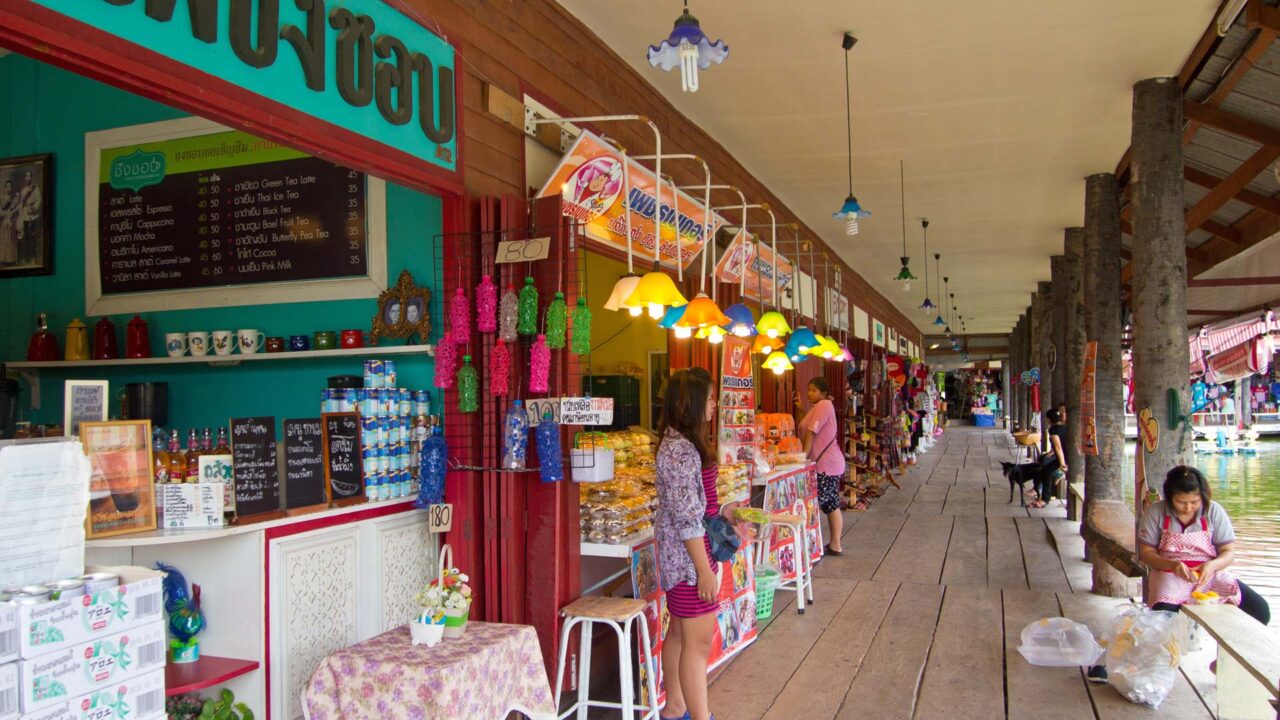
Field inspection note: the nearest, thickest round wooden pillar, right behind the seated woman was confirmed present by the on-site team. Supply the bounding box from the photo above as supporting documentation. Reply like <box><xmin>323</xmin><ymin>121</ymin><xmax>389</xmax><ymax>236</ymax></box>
<box><xmin>1132</xmin><ymin>78</ymin><xmax>1192</xmax><ymax>481</ymax></box>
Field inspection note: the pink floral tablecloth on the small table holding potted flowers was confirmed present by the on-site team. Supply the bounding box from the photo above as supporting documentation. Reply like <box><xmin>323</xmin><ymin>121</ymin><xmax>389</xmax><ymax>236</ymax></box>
<box><xmin>302</xmin><ymin>623</ymin><xmax>556</xmax><ymax>720</ymax></box>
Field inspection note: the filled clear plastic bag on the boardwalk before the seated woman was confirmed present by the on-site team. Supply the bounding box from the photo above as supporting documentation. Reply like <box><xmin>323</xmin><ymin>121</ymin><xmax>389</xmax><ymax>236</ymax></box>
<box><xmin>1107</xmin><ymin>605</ymin><xmax>1184</xmax><ymax>708</ymax></box>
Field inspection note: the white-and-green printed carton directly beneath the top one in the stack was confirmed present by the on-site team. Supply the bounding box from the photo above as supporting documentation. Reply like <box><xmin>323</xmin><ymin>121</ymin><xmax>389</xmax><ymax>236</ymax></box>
<box><xmin>18</xmin><ymin>620</ymin><xmax>168</xmax><ymax>714</ymax></box>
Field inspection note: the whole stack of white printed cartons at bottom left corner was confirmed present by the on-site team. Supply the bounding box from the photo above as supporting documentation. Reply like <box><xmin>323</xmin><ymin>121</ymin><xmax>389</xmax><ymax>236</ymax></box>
<box><xmin>0</xmin><ymin>568</ymin><xmax>168</xmax><ymax>720</ymax></box>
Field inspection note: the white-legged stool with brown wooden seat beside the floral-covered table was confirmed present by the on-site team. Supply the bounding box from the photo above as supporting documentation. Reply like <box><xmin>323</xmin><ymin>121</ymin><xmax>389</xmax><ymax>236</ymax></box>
<box><xmin>556</xmin><ymin>597</ymin><xmax>658</xmax><ymax>720</ymax></box>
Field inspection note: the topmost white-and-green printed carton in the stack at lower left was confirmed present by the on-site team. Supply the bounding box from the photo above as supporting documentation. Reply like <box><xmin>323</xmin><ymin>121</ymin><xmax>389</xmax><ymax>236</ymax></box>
<box><xmin>18</xmin><ymin>565</ymin><xmax>164</xmax><ymax>659</ymax></box>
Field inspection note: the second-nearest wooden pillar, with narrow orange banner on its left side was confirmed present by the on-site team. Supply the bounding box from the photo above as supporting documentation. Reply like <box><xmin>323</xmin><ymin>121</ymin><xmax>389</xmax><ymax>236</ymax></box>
<box><xmin>1082</xmin><ymin>173</ymin><xmax>1133</xmax><ymax>597</ymax></box>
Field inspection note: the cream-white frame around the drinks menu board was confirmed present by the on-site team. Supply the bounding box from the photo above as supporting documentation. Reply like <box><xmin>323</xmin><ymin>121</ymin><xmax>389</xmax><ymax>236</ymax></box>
<box><xmin>84</xmin><ymin>118</ymin><xmax>387</xmax><ymax>315</ymax></box>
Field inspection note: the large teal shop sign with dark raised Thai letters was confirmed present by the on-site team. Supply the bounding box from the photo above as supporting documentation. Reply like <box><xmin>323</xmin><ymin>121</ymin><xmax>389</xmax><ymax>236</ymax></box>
<box><xmin>31</xmin><ymin>0</ymin><xmax>458</xmax><ymax>172</ymax></box>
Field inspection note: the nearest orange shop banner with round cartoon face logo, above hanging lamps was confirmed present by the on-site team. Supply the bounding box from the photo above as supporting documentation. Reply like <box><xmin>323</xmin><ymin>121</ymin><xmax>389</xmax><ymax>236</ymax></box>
<box><xmin>538</xmin><ymin>132</ymin><xmax>724</xmax><ymax>268</ymax></box>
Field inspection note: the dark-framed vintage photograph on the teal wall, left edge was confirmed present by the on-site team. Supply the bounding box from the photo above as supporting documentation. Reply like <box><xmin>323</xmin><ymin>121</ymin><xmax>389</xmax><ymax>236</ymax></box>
<box><xmin>0</xmin><ymin>155</ymin><xmax>54</xmax><ymax>278</ymax></box>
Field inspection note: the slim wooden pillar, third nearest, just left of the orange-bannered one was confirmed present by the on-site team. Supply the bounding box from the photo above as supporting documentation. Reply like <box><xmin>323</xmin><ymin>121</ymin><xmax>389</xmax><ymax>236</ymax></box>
<box><xmin>1057</xmin><ymin>228</ymin><xmax>1084</xmax><ymax>520</ymax></box>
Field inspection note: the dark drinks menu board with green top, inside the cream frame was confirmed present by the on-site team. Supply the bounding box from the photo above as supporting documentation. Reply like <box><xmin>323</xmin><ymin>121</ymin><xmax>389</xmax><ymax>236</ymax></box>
<box><xmin>99</xmin><ymin>131</ymin><xmax>369</xmax><ymax>295</ymax></box>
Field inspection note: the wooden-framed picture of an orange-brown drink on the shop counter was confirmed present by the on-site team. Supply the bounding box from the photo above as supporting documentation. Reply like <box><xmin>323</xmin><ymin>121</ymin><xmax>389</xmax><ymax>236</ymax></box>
<box><xmin>79</xmin><ymin>420</ymin><xmax>156</xmax><ymax>539</ymax></box>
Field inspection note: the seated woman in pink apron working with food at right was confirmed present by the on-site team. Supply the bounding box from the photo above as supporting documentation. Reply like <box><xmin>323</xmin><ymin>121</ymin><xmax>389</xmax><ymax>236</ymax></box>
<box><xmin>1089</xmin><ymin>465</ymin><xmax>1271</xmax><ymax>682</ymax></box>
